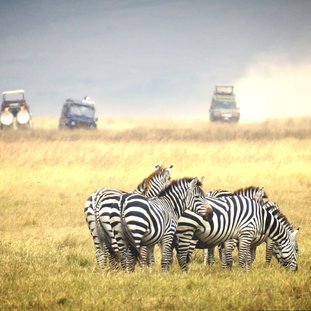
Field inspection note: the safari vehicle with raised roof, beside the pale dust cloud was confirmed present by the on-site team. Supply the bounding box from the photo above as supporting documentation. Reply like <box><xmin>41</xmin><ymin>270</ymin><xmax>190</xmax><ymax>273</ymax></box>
<box><xmin>209</xmin><ymin>85</ymin><xmax>240</xmax><ymax>123</ymax></box>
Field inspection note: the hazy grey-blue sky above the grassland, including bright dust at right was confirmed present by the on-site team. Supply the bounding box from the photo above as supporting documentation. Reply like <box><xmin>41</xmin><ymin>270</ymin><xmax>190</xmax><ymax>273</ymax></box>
<box><xmin>0</xmin><ymin>0</ymin><xmax>311</xmax><ymax>121</ymax></box>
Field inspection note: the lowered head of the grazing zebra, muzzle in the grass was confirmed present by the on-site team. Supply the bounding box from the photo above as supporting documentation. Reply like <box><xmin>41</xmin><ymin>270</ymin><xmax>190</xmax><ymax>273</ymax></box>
<box><xmin>273</xmin><ymin>228</ymin><xmax>299</xmax><ymax>271</ymax></box>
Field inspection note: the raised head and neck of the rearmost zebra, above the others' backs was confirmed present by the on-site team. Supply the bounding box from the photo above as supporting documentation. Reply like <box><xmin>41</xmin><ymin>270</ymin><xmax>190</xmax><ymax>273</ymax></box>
<box><xmin>135</xmin><ymin>164</ymin><xmax>173</xmax><ymax>198</ymax></box>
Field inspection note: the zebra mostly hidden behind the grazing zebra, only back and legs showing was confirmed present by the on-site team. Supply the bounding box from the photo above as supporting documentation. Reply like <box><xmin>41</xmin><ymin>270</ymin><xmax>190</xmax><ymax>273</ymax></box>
<box><xmin>203</xmin><ymin>186</ymin><xmax>271</xmax><ymax>268</ymax></box>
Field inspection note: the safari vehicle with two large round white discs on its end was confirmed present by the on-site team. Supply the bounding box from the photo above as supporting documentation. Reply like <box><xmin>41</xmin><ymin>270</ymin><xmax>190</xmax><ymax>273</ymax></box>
<box><xmin>0</xmin><ymin>90</ymin><xmax>32</xmax><ymax>129</ymax></box>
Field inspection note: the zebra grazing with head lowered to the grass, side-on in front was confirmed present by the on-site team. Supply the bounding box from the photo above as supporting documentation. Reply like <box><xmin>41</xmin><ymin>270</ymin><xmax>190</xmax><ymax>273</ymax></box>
<box><xmin>176</xmin><ymin>195</ymin><xmax>298</xmax><ymax>271</ymax></box>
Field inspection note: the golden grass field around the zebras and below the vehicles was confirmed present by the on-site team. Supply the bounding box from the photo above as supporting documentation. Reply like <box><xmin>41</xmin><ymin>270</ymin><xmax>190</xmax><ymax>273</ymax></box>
<box><xmin>0</xmin><ymin>118</ymin><xmax>311</xmax><ymax>310</ymax></box>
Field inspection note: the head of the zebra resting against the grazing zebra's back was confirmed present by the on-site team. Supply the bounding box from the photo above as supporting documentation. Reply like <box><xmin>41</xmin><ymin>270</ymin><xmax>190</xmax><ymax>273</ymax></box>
<box><xmin>186</xmin><ymin>177</ymin><xmax>213</xmax><ymax>217</ymax></box>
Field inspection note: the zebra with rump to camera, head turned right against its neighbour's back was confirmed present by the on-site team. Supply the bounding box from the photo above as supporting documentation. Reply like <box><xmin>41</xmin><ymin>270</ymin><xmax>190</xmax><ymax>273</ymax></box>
<box><xmin>120</xmin><ymin>178</ymin><xmax>212</xmax><ymax>272</ymax></box>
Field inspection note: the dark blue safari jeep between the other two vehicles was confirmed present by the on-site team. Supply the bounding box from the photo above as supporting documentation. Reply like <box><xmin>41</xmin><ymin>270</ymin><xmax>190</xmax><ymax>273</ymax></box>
<box><xmin>58</xmin><ymin>97</ymin><xmax>97</xmax><ymax>129</ymax></box>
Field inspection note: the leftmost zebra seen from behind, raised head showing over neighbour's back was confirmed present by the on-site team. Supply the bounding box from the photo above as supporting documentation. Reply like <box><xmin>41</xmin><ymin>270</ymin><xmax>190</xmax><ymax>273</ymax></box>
<box><xmin>84</xmin><ymin>165</ymin><xmax>173</xmax><ymax>269</ymax></box>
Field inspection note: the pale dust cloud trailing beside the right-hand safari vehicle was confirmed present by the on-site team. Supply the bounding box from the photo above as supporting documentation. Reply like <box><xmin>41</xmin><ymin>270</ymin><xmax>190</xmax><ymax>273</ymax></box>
<box><xmin>234</xmin><ymin>58</ymin><xmax>311</xmax><ymax>122</ymax></box>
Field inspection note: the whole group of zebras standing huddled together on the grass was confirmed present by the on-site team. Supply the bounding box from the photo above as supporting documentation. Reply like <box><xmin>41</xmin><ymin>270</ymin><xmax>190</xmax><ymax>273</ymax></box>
<box><xmin>84</xmin><ymin>165</ymin><xmax>299</xmax><ymax>272</ymax></box>
